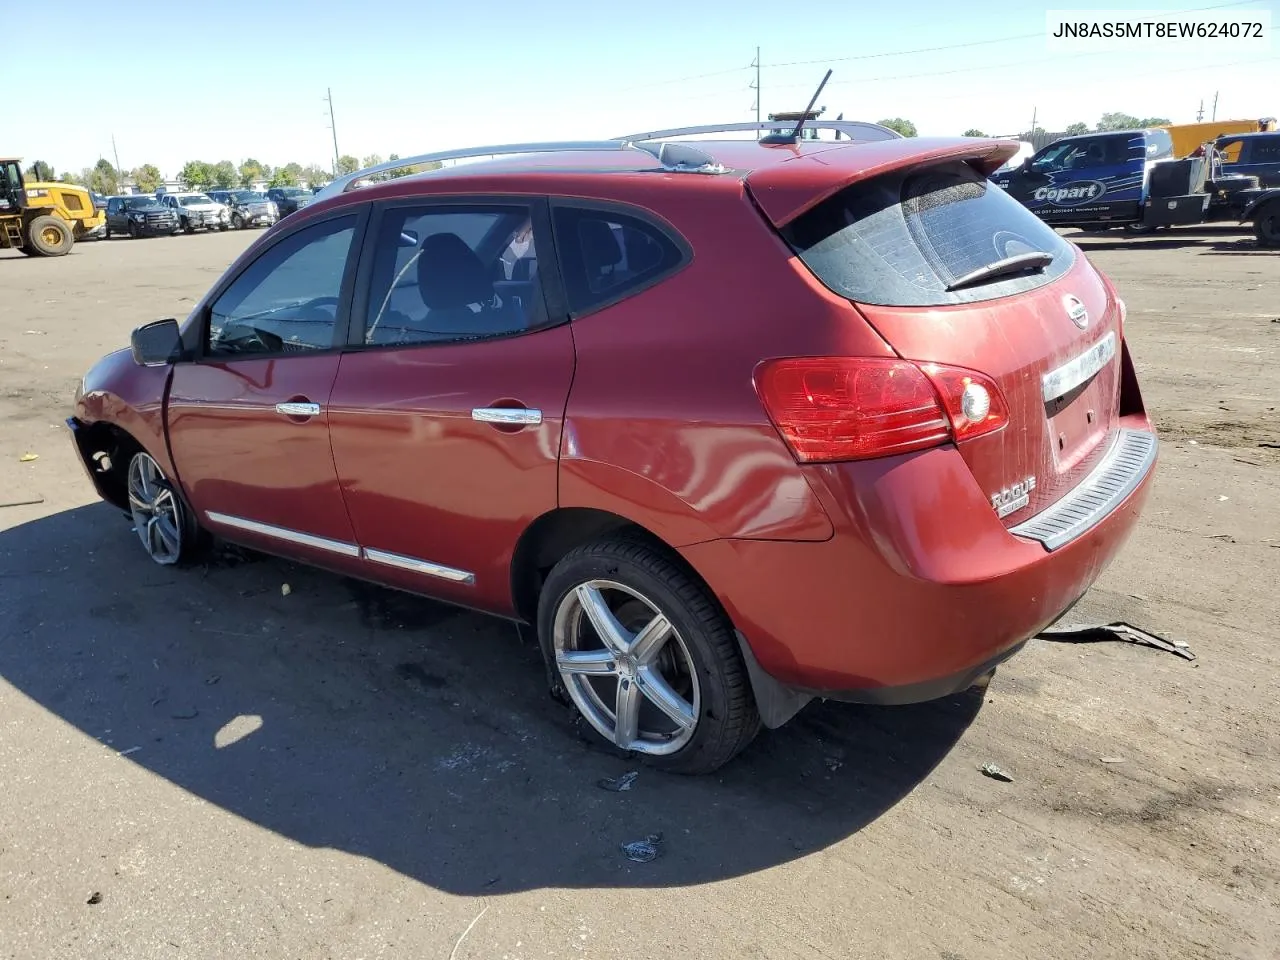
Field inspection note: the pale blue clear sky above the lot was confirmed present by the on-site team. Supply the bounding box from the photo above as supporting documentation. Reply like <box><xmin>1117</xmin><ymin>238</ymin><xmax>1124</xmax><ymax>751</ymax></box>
<box><xmin>12</xmin><ymin>0</ymin><xmax>1280</xmax><ymax>177</ymax></box>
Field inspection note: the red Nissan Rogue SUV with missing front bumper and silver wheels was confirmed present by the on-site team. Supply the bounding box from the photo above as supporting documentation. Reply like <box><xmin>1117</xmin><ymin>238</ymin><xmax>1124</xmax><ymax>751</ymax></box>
<box><xmin>69</xmin><ymin>124</ymin><xmax>1157</xmax><ymax>772</ymax></box>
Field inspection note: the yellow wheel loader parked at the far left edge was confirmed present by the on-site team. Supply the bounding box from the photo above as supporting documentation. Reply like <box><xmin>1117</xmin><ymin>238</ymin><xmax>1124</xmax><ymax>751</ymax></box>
<box><xmin>0</xmin><ymin>156</ymin><xmax>106</xmax><ymax>257</ymax></box>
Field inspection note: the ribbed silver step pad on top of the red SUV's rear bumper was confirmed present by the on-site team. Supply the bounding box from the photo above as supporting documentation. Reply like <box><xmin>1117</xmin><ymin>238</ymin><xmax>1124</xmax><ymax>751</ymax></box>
<box><xmin>1009</xmin><ymin>430</ymin><xmax>1160</xmax><ymax>550</ymax></box>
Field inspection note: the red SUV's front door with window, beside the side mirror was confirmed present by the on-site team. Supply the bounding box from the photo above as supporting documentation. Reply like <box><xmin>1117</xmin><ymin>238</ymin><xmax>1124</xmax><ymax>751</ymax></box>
<box><xmin>168</xmin><ymin>206</ymin><xmax>367</xmax><ymax>563</ymax></box>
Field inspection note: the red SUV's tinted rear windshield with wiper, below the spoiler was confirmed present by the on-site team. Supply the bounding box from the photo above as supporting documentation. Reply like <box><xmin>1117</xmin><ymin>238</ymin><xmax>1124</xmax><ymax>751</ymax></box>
<box><xmin>783</xmin><ymin>161</ymin><xmax>1075</xmax><ymax>307</ymax></box>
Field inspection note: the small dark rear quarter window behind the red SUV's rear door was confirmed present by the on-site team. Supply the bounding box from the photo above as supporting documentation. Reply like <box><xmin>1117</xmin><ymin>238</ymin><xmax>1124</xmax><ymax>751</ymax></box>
<box><xmin>552</xmin><ymin>206</ymin><xmax>686</xmax><ymax>316</ymax></box>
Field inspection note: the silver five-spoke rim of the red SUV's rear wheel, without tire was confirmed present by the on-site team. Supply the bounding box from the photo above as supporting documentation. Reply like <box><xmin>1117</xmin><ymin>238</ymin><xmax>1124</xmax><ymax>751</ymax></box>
<box><xmin>552</xmin><ymin>580</ymin><xmax>701</xmax><ymax>755</ymax></box>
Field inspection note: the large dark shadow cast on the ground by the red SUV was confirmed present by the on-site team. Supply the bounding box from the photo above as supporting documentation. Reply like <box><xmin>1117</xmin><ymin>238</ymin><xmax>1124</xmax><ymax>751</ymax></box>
<box><xmin>0</xmin><ymin>504</ymin><xmax>983</xmax><ymax>895</ymax></box>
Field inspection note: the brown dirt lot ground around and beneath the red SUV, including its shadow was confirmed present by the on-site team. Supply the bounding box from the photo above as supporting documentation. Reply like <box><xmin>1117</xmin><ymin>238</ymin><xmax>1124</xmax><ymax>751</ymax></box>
<box><xmin>0</xmin><ymin>230</ymin><xmax>1280</xmax><ymax>960</ymax></box>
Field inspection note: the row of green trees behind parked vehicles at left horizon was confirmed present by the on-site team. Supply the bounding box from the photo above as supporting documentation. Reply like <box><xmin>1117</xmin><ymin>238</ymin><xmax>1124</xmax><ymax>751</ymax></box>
<box><xmin>26</xmin><ymin>154</ymin><xmax>427</xmax><ymax>196</ymax></box>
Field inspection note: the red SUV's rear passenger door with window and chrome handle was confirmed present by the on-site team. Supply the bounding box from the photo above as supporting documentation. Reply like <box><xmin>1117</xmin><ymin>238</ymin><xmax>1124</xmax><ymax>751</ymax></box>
<box><xmin>329</xmin><ymin>198</ymin><xmax>573</xmax><ymax>613</ymax></box>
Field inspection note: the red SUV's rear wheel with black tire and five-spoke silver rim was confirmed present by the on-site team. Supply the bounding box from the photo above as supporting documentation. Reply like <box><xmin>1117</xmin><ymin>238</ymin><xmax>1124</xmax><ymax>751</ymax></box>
<box><xmin>538</xmin><ymin>539</ymin><xmax>760</xmax><ymax>773</ymax></box>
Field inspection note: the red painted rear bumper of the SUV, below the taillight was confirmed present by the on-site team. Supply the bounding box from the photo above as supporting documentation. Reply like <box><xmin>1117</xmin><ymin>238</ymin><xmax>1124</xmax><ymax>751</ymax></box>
<box><xmin>681</xmin><ymin>416</ymin><xmax>1155</xmax><ymax>703</ymax></box>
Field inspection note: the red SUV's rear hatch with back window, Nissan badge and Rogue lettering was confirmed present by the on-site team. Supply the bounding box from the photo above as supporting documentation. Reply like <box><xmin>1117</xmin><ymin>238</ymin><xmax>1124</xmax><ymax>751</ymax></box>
<box><xmin>782</xmin><ymin>160</ymin><xmax>1121</xmax><ymax>526</ymax></box>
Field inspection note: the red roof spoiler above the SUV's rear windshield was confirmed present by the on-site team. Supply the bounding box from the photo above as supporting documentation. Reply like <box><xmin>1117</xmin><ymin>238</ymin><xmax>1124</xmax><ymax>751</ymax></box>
<box><xmin>746</xmin><ymin>137</ymin><xmax>1018</xmax><ymax>227</ymax></box>
